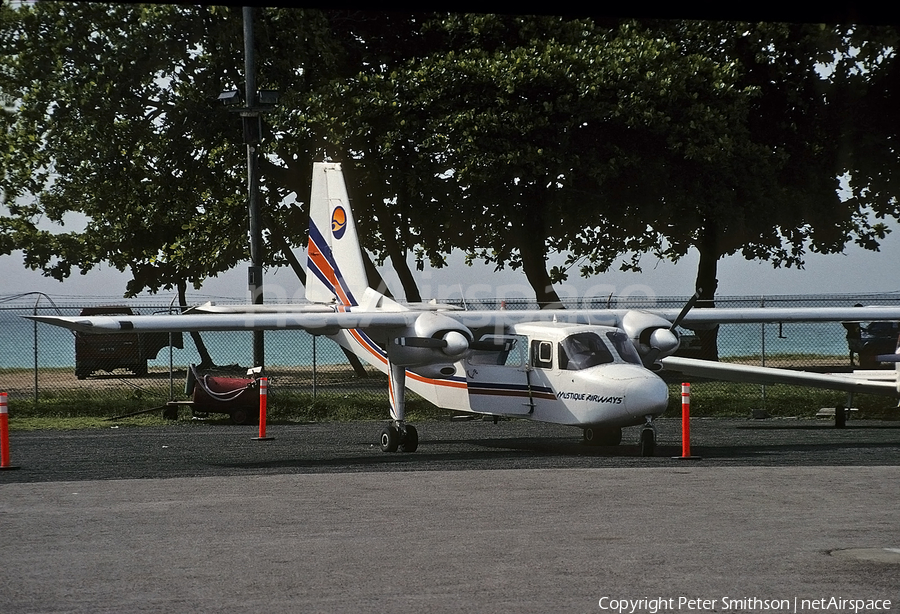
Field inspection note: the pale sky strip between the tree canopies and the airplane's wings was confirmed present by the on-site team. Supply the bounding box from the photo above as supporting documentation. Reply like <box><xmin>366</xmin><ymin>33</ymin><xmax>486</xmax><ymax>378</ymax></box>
<box><xmin>0</xmin><ymin>221</ymin><xmax>900</xmax><ymax>303</ymax></box>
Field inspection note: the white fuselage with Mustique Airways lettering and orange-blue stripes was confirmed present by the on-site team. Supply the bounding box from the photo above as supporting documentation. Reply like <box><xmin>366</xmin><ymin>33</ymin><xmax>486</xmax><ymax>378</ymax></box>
<box><xmin>332</xmin><ymin>322</ymin><xmax>668</xmax><ymax>427</ymax></box>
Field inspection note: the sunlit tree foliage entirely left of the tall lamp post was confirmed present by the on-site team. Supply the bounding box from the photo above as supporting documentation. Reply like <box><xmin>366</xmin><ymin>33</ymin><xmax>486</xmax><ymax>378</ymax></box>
<box><xmin>0</xmin><ymin>2</ymin><xmax>253</xmax><ymax>295</ymax></box>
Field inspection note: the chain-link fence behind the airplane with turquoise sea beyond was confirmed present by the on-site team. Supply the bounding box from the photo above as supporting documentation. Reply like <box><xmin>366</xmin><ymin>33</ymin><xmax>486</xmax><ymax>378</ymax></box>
<box><xmin>0</xmin><ymin>294</ymin><xmax>900</xmax><ymax>416</ymax></box>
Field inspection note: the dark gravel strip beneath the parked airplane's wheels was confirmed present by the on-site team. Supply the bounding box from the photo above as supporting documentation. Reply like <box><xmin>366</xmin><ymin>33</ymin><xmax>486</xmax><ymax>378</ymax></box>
<box><xmin>0</xmin><ymin>418</ymin><xmax>900</xmax><ymax>484</ymax></box>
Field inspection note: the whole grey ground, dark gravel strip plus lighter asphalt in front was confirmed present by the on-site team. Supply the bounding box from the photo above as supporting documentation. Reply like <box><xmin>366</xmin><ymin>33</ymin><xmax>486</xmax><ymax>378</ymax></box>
<box><xmin>0</xmin><ymin>419</ymin><xmax>900</xmax><ymax>614</ymax></box>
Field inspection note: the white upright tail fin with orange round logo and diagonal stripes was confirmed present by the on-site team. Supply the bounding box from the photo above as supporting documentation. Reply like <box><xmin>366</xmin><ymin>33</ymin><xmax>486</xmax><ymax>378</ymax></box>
<box><xmin>306</xmin><ymin>162</ymin><xmax>369</xmax><ymax>306</ymax></box>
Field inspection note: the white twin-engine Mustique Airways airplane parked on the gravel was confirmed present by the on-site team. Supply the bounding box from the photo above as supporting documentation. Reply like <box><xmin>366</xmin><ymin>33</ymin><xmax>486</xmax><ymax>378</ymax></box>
<box><xmin>29</xmin><ymin>163</ymin><xmax>900</xmax><ymax>456</ymax></box>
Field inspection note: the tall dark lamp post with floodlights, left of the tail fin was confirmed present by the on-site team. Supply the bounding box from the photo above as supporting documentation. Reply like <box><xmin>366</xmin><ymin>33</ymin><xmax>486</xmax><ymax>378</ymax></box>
<box><xmin>219</xmin><ymin>6</ymin><xmax>278</xmax><ymax>368</ymax></box>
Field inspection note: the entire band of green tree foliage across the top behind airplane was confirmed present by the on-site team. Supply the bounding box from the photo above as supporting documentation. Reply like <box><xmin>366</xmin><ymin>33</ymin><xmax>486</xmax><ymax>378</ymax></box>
<box><xmin>0</xmin><ymin>1</ymin><xmax>900</xmax><ymax>301</ymax></box>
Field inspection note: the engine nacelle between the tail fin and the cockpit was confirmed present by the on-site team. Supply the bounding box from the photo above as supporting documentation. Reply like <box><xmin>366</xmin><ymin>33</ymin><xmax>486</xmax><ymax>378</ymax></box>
<box><xmin>388</xmin><ymin>312</ymin><xmax>472</xmax><ymax>366</ymax></box>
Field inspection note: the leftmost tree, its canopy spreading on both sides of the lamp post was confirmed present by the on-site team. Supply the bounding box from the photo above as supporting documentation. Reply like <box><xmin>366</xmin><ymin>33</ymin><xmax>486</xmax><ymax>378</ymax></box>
<box><xmin>0</xmin><ymin>2</ymin><xmax>434</xmax><ymax>304</ymax></box>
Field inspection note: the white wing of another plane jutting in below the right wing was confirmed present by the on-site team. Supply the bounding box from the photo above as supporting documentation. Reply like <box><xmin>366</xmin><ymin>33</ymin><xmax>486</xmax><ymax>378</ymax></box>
<box><xmin>660</xmin><ymin>356</ymin><xmax>900</xmax><ymax>398</ymax></box>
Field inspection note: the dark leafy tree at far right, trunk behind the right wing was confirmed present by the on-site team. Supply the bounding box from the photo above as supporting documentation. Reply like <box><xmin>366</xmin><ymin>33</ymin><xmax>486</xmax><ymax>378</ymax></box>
<box><xmin>560</xmin><ymin>21</ymin><xmax>895</xmax><ymax>312</ymax></box>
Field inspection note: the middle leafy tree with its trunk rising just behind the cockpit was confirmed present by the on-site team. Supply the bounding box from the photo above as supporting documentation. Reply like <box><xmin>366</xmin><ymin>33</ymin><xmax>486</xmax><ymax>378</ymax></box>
<box><xmin>300</xmin><ymin>15</ymin><xmax>676</xmax><ymax>304</ymax></box>
